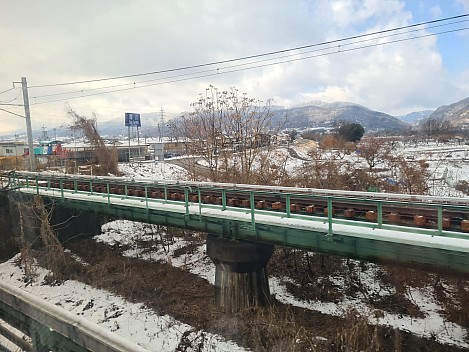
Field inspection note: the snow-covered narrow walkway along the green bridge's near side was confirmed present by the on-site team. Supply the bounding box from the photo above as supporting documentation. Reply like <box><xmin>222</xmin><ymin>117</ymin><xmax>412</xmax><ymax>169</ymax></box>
<box><xmin>18</xmin><ymin>187</ymin><xmax>469</xmax><ymax>253</ymax></box>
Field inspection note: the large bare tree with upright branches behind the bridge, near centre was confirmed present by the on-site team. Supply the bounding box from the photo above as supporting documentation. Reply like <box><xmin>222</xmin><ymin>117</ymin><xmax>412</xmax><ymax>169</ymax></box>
<box><xmin>178</xmin><ymin>86</ymin><xmax>280</xmax><ymax>183</ymax></box>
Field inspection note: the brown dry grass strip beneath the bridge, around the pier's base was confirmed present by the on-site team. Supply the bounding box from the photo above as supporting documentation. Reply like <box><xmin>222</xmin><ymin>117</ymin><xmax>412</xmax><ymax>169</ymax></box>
<box><xmin>58</xmin><ymin>233</ymin><xmax>468</xmax><ymax>352</ymax></box>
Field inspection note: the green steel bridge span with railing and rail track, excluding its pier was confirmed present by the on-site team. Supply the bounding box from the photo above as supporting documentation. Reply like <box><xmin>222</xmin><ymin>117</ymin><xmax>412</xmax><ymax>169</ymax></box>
<box><xmin>3</xmin><ymin>172</ymin><xmax>469</xmax><ymax>274</ymax></box>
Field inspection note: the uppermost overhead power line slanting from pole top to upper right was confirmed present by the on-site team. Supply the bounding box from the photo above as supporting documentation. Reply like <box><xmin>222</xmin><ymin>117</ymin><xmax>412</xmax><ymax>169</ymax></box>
<box><xmin>29</xmin><ymin>14</ymin><xmax>469</xmax><ymax>88</ymax></box>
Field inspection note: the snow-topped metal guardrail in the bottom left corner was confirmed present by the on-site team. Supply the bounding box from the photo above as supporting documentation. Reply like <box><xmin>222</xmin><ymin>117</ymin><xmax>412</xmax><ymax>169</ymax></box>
<box><xmin>0</xmin><ymin>282</ymin><xmax>147</xmax><ymax>352</ymax></box>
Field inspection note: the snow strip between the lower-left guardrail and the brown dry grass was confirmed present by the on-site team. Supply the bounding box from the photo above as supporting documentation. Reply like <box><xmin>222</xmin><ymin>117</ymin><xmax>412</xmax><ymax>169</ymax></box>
<box><xmin>0</xmin><ymin>254</ymin><xmax>245</xmax><ymax>352</ymax></box>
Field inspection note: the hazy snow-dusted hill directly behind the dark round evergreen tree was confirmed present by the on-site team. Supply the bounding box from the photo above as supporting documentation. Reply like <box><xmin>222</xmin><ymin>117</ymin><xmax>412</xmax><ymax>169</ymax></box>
<box><xmin>273</xmin><ymin>102</ymin><xmax>408</xmax><ymax>132</ymax></box>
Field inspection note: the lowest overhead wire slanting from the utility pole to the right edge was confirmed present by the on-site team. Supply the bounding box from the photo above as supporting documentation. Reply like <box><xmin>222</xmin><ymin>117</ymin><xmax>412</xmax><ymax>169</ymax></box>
<box><xmin>30</xmin><ymin>27</ymin><xmax>469</xmax><ymax>105</ymax></box>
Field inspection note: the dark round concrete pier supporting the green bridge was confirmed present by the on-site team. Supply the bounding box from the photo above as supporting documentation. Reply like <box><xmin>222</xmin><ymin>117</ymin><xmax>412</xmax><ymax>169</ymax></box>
<box><xmin>207</xmin><ymin>234</ymin><xmax>274</xmax><ymax>313</ymax></box>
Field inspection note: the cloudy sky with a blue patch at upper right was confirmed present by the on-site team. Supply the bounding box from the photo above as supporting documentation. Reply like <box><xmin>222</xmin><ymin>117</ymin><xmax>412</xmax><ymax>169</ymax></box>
<box><xmin>0</xmin><ymin>0</ymin><xmax>469</xmax><ymax>134</ymax></box>
